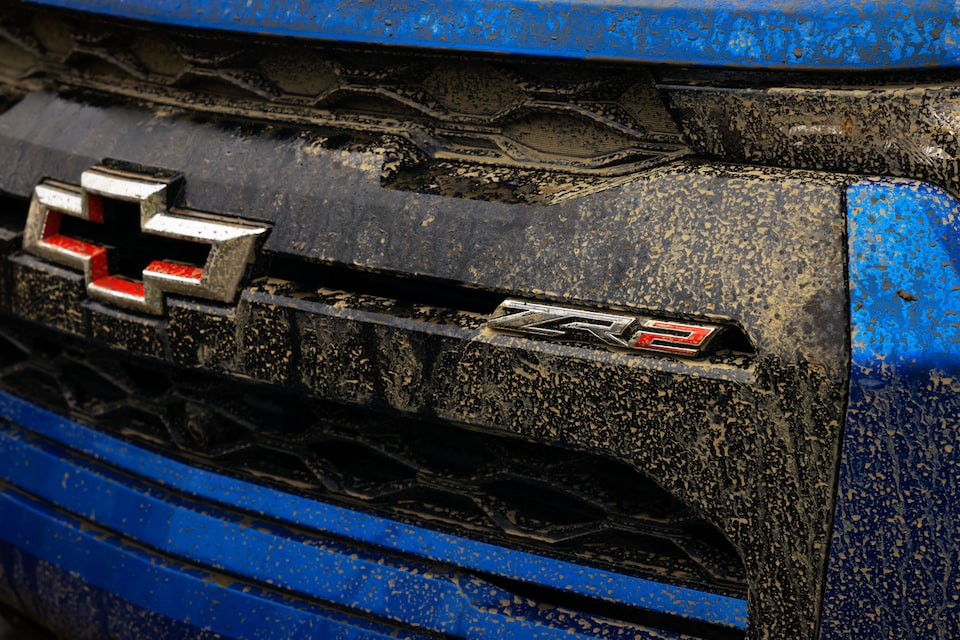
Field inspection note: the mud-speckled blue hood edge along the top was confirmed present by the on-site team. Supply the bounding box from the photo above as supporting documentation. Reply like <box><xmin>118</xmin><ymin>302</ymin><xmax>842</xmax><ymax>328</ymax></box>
<box><xmin>20</xmin><ymin>0</ymin><xmax>960</xmax><ymax>69</ymax></box>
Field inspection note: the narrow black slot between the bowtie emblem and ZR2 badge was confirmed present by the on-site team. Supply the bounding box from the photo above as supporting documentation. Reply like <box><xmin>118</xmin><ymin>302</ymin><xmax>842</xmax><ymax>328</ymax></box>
<box><xmin>269</xmin><ymin>256</ymin><xmax>503</xmax><ymax>315</ymax></box>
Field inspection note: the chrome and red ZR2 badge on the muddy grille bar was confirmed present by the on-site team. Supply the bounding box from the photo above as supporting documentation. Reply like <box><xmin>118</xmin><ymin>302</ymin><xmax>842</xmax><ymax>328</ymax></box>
<box><xmin>487</xmin><ymin>299</ymin><xmax>723</xmax><ymax>357</ymax></box>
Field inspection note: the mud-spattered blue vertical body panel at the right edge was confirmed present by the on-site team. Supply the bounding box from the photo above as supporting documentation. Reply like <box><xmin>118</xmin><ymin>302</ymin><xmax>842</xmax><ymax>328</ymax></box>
<box><xmin>821</xmin><ymin>179</ymin><xmax>960</xmax><ymax>640</ymax></box>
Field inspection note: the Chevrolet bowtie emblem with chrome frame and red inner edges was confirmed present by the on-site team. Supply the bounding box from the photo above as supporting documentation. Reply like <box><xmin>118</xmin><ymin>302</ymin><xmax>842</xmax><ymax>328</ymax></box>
<box><xmin>23</xmin><ymin>164</ymin><xmax>267</xmax><ymax>314</ymax></box>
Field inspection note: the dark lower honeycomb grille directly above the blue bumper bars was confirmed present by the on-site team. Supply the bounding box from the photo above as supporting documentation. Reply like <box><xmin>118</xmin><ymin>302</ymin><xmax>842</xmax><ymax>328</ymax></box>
<box><xmin>0</xmin><ymin>318</ymin><xmax>746</xmax><ymax>597</ymax></box>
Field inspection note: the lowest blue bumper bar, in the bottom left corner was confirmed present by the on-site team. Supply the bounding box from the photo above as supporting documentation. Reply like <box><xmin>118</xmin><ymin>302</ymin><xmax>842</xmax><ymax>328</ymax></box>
<box><xmin>0</xmin><ymin>488</ymin><xmax>410</xmax><ymax>640</ymax></box>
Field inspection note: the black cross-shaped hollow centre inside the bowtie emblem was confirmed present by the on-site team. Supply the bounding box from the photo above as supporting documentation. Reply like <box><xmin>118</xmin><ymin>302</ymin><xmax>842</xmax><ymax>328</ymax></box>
<box><xmin>60</xmin><ymin>198</ymin><xmax>210</xmax><ymax>280</ymax></box>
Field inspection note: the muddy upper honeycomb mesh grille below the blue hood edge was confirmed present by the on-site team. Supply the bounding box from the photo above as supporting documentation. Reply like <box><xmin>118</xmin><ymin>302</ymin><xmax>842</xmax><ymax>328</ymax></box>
<box><xmin>0</xmin><ymin>8</ymin><xmax>687</xmax><ymax>175</ymax></box>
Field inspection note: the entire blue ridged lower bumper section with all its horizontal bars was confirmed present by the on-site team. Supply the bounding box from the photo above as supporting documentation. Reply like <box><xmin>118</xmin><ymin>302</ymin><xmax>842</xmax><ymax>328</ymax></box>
<box><xmin>0</xmin><ymin>388</ymin><xmax>746</xmax><ymax>638</ymax></box>
